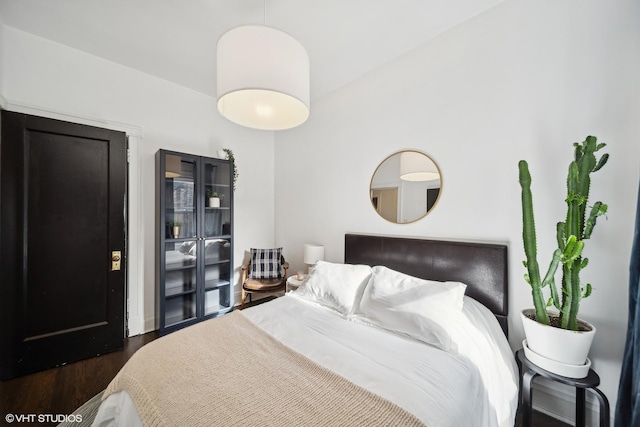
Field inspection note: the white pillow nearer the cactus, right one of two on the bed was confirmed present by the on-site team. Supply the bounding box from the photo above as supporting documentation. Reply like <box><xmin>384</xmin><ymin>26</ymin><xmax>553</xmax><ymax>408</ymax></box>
<box><xmin>355</xmin><ymin>266</ymin><xmax>466</xmax><ymax>352</ymax></box>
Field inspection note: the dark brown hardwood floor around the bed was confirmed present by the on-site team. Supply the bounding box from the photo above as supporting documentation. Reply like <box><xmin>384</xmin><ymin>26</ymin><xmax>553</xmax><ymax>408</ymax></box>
<box><xmin>0</xmin><ymin>303</ymin><xmax>568</xmax><ymax>427</ymax></box>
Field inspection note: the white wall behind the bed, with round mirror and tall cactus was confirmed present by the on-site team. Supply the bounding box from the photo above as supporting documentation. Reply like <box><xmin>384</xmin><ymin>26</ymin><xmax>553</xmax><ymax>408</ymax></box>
<box><xmin>275</xmin><ymin>0</ymin><xmax>640</xmax><ymax>419</ymax></box>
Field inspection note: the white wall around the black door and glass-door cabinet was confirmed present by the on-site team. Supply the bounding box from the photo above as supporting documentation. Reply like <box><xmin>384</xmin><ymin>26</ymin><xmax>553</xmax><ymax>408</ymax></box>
<box><xmin>0</xmin><ymin>26</ymin><xmax>274</xmax><ymax>331</ymax></box>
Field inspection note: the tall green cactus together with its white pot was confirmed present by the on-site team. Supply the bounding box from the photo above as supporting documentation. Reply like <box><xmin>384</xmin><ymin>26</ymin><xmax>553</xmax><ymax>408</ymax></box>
<box><xmin>518</xmin><ymin>136</ymin><xmax>609</xmax><ymax>376</ymax></box>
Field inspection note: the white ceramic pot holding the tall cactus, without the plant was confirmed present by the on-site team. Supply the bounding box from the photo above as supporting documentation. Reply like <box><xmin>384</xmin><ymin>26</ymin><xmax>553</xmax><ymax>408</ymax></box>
<box><xmin>521</xmin><ymin>308</ymin><xmax>596</xmax><ymax>366</ymax></box>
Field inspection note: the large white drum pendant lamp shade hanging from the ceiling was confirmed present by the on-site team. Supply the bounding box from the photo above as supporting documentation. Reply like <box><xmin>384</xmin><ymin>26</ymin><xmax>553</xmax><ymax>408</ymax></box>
<box><xmin>217</xmin><ymin>25</ymin><xmax>310</xmax><ymax>130</ymax></box>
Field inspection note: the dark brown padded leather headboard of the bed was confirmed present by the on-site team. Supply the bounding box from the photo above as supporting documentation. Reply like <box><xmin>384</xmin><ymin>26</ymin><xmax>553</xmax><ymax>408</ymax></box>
<box><xmin>344</xmin><ymin>234</ymin><xmax>509</xmax><ymax>336</ymax></box>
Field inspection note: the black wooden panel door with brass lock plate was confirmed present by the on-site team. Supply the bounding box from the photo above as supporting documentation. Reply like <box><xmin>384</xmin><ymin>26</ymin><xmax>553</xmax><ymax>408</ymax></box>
<box><xmin>0</xmin><ymin>111</ymin><xmax>127</xmax><ymax>379</ymax></box>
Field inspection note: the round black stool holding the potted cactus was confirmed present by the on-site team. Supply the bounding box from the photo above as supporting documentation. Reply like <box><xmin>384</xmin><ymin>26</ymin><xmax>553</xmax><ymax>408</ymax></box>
<box><xmin>516</xmin><ymin>349</ymin><xmax>610</xmax><ymax>427</ymax></box>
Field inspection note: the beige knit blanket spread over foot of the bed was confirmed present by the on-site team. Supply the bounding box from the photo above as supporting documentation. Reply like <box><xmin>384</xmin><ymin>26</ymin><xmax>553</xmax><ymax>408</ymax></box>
<box><xmin>103</xmin><ymin>311</ymin><xmax>423</xmax><ymax>427</ymax></box>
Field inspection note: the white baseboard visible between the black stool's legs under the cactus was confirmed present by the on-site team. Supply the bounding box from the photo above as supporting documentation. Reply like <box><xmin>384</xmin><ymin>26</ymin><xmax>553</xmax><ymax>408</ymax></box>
<box><xmin>532</xmin><ymin>378</ymin><xmax>613</xmax><ymax>426</ymax></box>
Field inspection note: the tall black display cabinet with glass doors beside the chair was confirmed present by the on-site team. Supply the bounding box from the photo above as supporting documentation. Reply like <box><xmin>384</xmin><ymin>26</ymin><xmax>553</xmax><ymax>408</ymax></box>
<box><xmin>156</xmin><ymin>150</ymin><xmax>233</xmax><ymax>335</ymax></box>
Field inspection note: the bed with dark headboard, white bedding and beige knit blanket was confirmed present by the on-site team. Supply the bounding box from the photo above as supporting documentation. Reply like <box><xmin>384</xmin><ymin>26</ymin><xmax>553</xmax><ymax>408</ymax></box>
<box><xmin>94</xmin><ymin>234</ymin><xmax>518</xmax><ymax>427</ymax></box>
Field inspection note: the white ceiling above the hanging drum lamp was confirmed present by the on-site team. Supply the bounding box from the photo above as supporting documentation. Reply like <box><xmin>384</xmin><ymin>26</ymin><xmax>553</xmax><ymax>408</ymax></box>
<box><xmin>0</xmin><ymin>0</ymin><xmax>503</xmax><ymax>100</ymax></box>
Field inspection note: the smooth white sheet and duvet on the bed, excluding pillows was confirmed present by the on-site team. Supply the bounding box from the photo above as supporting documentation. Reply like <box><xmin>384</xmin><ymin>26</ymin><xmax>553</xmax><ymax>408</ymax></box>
<box><xmin>93</xmin><ymin>293</ymin><xmax>518</xmax><ymax>427</ymax></box>
